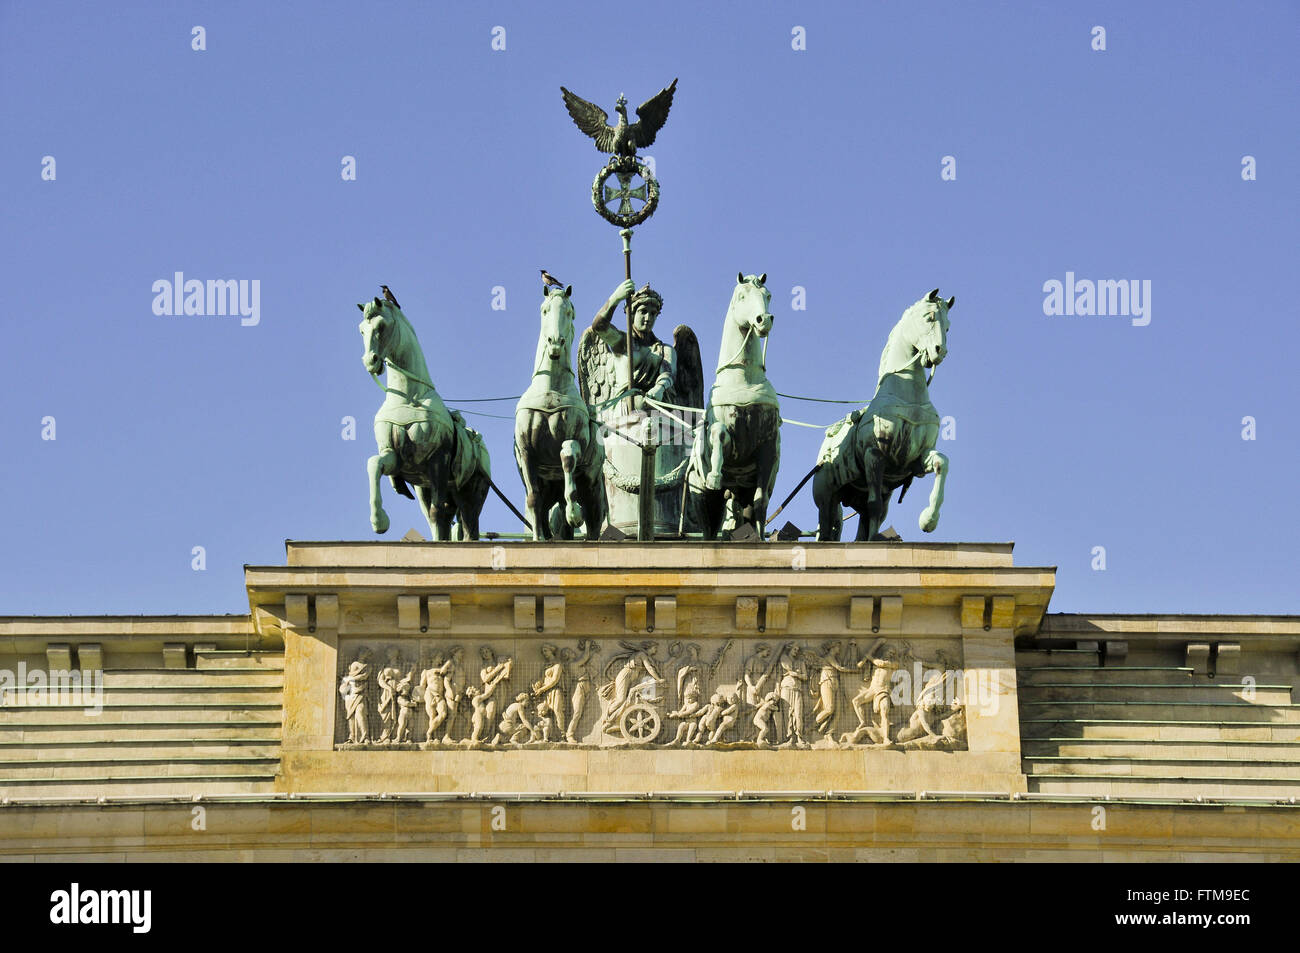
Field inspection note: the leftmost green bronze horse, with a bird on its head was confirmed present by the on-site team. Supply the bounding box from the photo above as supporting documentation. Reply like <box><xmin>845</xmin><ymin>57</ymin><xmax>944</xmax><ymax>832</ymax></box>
<box><xmin>356</xmin><ymin>287</ymin><xmax>491</xmax><ymax>540</ymax></box>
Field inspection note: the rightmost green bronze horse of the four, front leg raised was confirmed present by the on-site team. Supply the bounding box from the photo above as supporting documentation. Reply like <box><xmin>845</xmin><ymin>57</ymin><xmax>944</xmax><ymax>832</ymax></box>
<box><xmin>813</xmin><ymin>287</ymin><xmax>957</xmax><ymax>542</ymax></box>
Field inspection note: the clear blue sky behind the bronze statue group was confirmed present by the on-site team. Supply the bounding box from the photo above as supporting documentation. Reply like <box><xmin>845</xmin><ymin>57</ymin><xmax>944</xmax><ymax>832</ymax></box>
<box><xmin>0</xmin><ymin>1</ymin><xmax>1300</xmax><ymax>614</ymax></box>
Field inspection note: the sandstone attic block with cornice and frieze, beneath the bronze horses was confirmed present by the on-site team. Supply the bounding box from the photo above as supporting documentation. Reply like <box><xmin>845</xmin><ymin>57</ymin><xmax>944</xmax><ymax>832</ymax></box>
<box><xmin>247</xmin><ymin>542</ymin><xmax>1054</xmax><ymax>794</ymax></box>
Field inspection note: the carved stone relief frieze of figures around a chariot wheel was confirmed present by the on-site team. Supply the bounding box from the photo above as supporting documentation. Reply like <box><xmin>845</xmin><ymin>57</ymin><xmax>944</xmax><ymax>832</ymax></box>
<box><xmin>335</xmin><ymin>633</ymin><xmax>967</xmax><ymax>750</ymax></box>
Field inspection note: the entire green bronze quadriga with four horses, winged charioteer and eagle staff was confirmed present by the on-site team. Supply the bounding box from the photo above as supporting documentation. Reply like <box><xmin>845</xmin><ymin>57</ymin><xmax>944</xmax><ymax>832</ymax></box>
<box><xmin>358</xmin><ymin>79</ymin><xmax>954</xmax><ymax>541</ymax></box>
